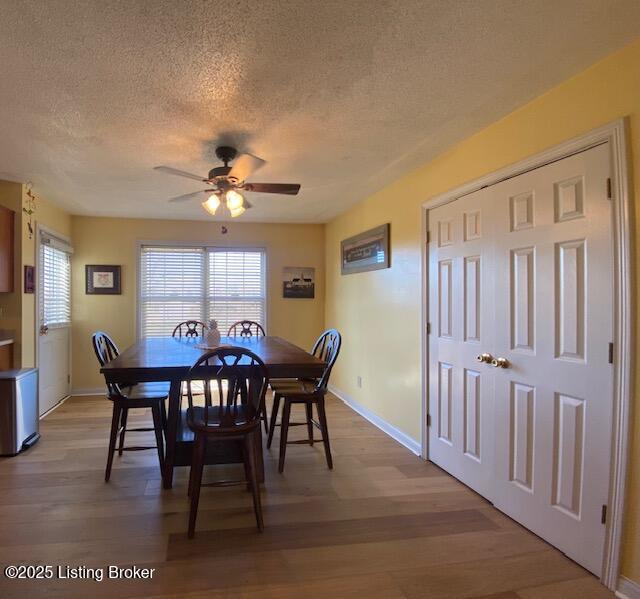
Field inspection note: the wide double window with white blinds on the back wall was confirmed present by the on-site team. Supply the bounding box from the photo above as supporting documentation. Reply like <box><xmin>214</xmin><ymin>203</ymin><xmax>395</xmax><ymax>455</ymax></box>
<box><xmin>139</xmin><ymin>246</ymin><xmax>266</xmax><ymax>337</ymax></box>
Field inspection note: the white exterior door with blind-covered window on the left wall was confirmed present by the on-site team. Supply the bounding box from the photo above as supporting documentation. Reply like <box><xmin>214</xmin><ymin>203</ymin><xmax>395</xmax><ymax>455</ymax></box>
<box><xmin>38</xmin><ymin>231</ymin><xmax>71</xmax><ymax>415</ymax></box>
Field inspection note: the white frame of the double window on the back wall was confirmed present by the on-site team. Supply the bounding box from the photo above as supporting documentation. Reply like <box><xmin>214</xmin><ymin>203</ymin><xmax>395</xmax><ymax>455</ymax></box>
<box><xmin>134</xmin><ymin>239</ymin><xmax>269</xmax><ymax>340</ymax></box>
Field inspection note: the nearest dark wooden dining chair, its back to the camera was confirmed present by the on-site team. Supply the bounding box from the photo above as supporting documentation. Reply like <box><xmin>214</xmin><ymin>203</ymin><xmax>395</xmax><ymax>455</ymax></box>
<box><xmin>187</xmin><ymin>347</ymin><xmax>269</xmax><ymax>539</ymax></box>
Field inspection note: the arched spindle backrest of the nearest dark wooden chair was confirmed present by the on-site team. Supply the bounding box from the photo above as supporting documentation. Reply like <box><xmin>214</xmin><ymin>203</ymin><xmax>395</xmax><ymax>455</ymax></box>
<box><xmin>187</xmin><ymin>347</ymin><xmax>269</xmax><ymax>432</ymax></box>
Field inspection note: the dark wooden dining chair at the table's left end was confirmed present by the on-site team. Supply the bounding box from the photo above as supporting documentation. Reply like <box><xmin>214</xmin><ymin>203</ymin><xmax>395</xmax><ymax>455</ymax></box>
<box><xmin>91</xmin><ymin>331</ymin><xmax>169</xmax><ymax>482</ymax></box>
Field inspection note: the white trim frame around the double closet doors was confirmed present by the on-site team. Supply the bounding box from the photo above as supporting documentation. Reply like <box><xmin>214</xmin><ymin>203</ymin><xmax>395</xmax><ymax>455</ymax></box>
<box><xmin>420</xmin><ymin>117</ymin><xmax>635</xmax><ymax>591</ymax></box>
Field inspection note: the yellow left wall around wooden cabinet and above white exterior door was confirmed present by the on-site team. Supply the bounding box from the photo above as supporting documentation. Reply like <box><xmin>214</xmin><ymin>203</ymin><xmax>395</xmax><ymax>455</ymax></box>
<box><xmin>0</xmin><ymin>181</ymin><xmax>71</xmax><ymax>367</ymax></box>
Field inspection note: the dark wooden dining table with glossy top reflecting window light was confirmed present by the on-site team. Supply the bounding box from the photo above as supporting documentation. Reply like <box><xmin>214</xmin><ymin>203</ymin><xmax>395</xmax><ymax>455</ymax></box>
<box><xmin>100</xmin><ymin>336</ymin><xmax>325</xmax><ymax>489</ymax></box>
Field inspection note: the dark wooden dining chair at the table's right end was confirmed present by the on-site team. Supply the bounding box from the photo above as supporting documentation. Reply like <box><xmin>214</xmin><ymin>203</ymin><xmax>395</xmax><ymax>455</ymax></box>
<box><xmin>267</xmin><ymin>329</ymin><xmax>342</xmax><ymax>472</ymax></box>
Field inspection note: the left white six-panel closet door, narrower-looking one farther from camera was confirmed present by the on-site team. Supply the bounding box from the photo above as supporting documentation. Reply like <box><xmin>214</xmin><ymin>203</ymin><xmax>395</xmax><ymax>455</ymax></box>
<box><xmin>429</xmin><ymin>189</ymin><xmax>494</xmax><ymax>498</ymax></box>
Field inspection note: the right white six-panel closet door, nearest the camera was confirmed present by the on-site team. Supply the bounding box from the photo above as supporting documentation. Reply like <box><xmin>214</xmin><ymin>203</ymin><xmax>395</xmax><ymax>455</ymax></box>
<box><xmin>489</xmin><ymin>144</ymin><xmax>614</xmax><ymax>574</ymax></box>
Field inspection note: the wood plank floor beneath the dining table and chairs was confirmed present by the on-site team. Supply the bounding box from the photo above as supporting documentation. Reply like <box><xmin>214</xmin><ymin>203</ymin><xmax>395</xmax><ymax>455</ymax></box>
<box><xmin>0</xmin><ymin>397</ymin><xmax>613</xmax><ymax>599</ymax></box>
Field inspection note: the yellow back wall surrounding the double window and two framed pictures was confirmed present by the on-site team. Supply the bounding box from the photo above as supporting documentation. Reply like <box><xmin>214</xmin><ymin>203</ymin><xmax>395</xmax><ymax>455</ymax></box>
<box><xmin>71</xmin><ymin>216</ymin><xmax>324</xmax><ymax>389</ymax></box>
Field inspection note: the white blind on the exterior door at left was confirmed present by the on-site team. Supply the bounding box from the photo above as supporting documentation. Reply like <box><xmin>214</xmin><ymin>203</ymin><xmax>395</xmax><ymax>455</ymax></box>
<box><xmin>39</xmin><ymin>235</ymin><xmax>71</xmax><ymax>327</ymax></box>
